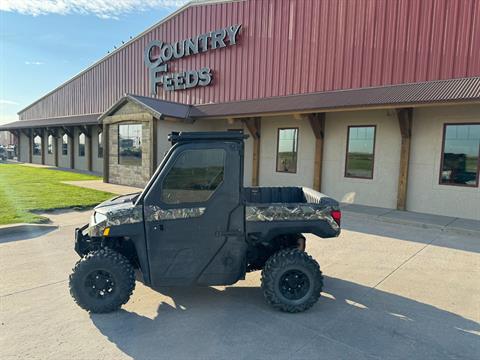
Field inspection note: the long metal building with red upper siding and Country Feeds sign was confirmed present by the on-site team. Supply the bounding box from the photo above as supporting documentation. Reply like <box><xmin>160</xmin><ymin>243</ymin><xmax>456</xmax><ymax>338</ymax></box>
<box><xmin>0</xmin><ymin>0</ymin><xmax>480</xmax><ymax>220</ymax></box>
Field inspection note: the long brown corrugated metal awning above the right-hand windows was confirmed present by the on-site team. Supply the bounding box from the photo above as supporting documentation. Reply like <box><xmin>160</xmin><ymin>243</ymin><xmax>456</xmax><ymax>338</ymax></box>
<box><xmin>190</xmin><ymin>77</ymin><xmax>480</xmax><ymax>118</ymax></box>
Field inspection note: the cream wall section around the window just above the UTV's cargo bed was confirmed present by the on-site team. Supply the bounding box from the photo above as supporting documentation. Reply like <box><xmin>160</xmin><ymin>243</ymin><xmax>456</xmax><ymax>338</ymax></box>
<box><xmin>259</xmin><ymin>115</ymin><xmax>315</xmax><ymax>187</ymax></box>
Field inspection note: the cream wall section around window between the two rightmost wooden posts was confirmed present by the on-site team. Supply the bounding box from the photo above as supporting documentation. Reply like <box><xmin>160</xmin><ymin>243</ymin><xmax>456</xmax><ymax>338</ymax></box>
<box><xmin>322</xmin><ymin>110</ymin><xmax>401</xmax><ymax>209</ymax></box>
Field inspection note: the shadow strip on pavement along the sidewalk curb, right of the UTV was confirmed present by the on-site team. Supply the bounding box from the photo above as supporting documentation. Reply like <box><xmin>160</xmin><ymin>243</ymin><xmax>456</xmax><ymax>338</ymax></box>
<box><xmin>342</xmin><ymin>215</ymin><xmax>480</xmax><ymax>253</ymax></box>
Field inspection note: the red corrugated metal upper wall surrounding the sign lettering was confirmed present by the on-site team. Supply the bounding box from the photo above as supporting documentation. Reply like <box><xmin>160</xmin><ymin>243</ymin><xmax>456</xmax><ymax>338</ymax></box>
<box><xmin>21</xmin><ymin>0</ymin><xmax>480</xmax><ymax>119</ymax></box>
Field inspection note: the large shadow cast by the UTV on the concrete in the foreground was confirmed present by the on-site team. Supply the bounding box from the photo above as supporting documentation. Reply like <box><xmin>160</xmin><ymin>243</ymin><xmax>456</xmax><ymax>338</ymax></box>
<box><xmin>91</xmin><ymin>278</ymin><xmax>480</xmax><ymax>359</ymax></box>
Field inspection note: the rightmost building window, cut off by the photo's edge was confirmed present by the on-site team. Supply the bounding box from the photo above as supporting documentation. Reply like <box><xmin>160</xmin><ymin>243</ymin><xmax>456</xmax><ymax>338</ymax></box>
<box><xmin>440</xmin><ymin>123</ymin><xmax>480</xmax><ymax>187</ymax></box>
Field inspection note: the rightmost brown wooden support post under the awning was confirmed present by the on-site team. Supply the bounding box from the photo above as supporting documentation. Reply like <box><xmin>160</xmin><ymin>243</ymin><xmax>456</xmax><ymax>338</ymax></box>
<box><xmin>396</xmin><ymin>108</ymin><xmax>413</xmax><ymax>210</ymax></box>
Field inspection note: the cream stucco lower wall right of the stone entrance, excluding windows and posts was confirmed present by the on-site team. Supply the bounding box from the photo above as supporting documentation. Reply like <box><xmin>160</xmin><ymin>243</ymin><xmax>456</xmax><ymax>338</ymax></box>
<box><xmin>143</xmin><ymin>105</ymin><xmax>480</xmax><ymax>220</ymax></box>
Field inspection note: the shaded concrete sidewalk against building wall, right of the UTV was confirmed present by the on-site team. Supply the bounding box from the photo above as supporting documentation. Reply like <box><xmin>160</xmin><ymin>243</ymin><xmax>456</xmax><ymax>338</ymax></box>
<box><xmin>341</xmin><ymin>204</ymin><xmax>480</xmax><ymax>236</ymax></box>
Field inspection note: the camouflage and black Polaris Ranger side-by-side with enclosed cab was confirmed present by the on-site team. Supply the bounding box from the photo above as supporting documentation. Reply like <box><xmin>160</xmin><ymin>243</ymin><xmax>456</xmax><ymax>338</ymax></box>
<box><xmin>70</xmin><ymin>131</ymin><xmax>341</xmax><ymax>312</ymax></box>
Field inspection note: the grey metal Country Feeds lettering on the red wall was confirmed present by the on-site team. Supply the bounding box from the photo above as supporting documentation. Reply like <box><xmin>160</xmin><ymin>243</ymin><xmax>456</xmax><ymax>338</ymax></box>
<box><xmin>144</xmin><ymin>24</ymin><xmax>242</xmax><ymax>95</ymax></box>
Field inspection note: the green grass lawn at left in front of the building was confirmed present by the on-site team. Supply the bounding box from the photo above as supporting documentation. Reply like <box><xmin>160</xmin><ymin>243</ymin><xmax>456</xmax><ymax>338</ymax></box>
<box><xmin>0</xmin><ymin>164</ymin><xmax>113</xmax><ymax>225</ymax></box>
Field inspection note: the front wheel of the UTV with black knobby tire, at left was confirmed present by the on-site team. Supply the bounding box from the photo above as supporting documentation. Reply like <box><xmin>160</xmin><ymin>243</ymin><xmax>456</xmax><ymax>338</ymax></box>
<box><xmin>70</xmin><ymin>249</ymin><xmax>135</xmax><ymax>313</ymax></box>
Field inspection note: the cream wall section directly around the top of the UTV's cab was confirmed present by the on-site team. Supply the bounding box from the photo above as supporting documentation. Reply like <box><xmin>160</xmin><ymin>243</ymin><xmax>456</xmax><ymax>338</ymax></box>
<box><xmin>157</xmin><ymin>120</ymin><xmax>253</xmax><ymax>186</ymax></box>
